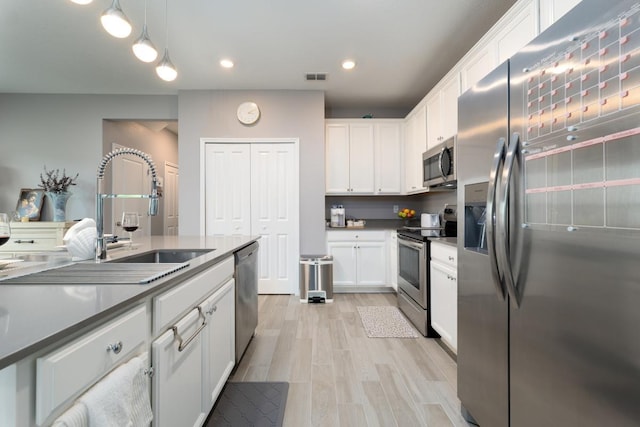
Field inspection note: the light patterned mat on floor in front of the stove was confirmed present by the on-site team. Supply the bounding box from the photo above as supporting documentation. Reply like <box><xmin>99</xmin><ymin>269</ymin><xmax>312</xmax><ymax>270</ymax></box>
<box><xmin>357</xmin><ymin>306</ymin><xmax>420</xmax><ymax>338</ymax></box>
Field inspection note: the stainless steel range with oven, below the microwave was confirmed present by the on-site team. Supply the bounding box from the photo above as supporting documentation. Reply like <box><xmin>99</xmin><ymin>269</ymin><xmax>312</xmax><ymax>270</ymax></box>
<box><xmin>397</xmin><ymin>205</ymin><xmax>457</xmax><ymax>338</ymax></box>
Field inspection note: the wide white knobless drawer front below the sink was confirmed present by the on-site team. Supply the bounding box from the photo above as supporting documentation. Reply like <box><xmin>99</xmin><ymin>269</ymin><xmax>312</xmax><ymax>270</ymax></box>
<box><xmin>153</xmin><ymin>257</ymin><xmax>234</xmax><ymax>336</ymax></box>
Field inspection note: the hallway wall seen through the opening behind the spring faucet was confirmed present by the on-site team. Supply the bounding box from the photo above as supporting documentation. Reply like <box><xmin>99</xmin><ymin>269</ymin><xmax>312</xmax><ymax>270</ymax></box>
<box><xmin>102</xmin><ymin>120</ymin><xmax>178</xmax><ymax>235</ymax></box>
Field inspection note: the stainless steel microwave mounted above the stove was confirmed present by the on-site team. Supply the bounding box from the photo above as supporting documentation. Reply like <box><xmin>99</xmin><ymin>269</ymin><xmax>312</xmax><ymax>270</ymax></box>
<box><xmin>422</xmin><ymin>136</ymin><xmax>458</xmax><ymax>190</ymax></box>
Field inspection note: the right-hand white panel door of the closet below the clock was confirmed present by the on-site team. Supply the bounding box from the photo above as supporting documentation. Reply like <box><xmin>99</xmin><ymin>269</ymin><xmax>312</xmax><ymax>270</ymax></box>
<box><xmin>251</xmin><ymin>144</ymin><xmax>299</xmax><ymax>294</ymax></box>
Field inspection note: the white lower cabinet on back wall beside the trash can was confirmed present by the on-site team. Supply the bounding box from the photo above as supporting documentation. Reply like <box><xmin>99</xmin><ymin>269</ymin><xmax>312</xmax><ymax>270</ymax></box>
<box><xmin>327</xmin><ymin>230</ymin><xmax>388</xmax><ymax>287</ymax></box>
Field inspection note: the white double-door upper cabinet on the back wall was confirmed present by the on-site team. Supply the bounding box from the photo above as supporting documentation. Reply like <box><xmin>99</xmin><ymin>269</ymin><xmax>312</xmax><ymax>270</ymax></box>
<box><xmin>325</xmin><ymin>119</ymin><xmax>402</xmax><ymax>194</ymax></box>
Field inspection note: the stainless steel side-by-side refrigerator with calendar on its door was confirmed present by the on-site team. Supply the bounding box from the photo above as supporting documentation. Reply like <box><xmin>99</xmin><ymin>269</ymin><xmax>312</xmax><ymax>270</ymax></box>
<box><xmin>457</xmin><ymin>0</ymin><xmax>640</xmax><ymax>427</ymax></box>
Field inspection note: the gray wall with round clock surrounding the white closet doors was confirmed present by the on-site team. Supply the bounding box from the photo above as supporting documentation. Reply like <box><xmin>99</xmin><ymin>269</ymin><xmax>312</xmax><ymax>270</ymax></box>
<box><xmin>178</xmin><ymin>91</ymin><xmax>325</xmax><ymax>253</ymax></box>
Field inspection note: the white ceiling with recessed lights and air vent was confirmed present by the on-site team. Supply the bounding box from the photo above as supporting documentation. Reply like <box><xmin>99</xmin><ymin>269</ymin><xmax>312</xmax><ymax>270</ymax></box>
<box><xmin>0</xmin><ymin>0</ymin><xmax>514</xmax><ymax>114</ymax></box>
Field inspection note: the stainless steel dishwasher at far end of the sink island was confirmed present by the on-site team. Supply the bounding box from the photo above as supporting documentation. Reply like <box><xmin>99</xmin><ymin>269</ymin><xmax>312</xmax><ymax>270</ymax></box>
<box><xmin>234</xmin><ymin>242</ymin><xmax>258</xmax><ymax>365</ymax></box>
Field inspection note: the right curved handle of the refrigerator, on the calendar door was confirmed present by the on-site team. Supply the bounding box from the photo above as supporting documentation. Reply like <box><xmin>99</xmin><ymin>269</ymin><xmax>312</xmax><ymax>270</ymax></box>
<box><xmin>496</xmin><ymin>132</ymin><xmax>520</xmax><ymax>308</ymax></box>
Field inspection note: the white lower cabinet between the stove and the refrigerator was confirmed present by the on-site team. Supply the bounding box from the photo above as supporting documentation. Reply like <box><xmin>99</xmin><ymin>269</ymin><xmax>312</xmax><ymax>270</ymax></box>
<box><xmin>430</xmin><ymin>242</ymin><xmax>458</xmax><ymax>352</ymax></box>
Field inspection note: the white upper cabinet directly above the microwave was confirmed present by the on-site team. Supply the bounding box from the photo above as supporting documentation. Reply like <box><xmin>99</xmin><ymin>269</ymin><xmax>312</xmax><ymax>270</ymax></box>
<box><xmin>427</xmin><ymin>70</ymin><xmax>460</xmax><ymax>149</ymax></box>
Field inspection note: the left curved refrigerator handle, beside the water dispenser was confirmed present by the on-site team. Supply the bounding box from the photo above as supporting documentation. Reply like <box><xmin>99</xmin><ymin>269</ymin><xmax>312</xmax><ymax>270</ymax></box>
<box><xmin>485</xmin><ymin>138</ymin><xmax>507</xmax><ymax>300</ymax></box>
